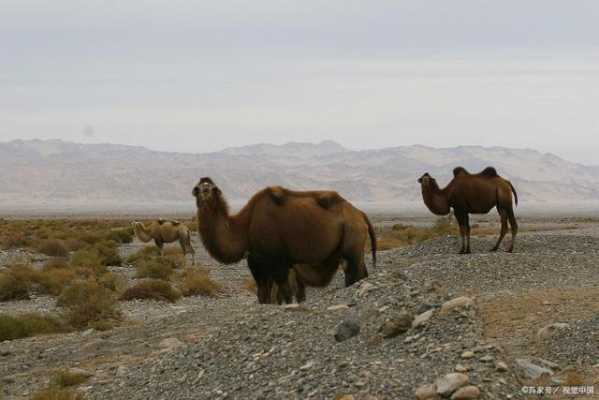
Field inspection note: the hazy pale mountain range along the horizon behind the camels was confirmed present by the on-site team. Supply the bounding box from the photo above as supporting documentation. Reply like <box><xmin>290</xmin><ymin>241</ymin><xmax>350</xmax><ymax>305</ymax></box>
<box><xmin>0</xmin><ymin>140</ymin><xmax>599</xmax><ymax>211</ymax></box>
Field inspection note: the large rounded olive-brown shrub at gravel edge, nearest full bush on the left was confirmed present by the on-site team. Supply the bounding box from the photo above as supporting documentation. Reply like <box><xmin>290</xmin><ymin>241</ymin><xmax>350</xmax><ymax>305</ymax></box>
<box><xmin>56</xmin><ymin>279</ymin><xmax>121</xmax><ymax>330</ymax></box>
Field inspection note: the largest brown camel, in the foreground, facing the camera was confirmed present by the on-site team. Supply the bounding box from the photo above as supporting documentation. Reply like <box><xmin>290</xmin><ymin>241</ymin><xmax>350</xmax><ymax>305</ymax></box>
<box><xmin>193</xmin><ymin>178</ymin><xmax>376</xmax><ymax>303</ymax></box>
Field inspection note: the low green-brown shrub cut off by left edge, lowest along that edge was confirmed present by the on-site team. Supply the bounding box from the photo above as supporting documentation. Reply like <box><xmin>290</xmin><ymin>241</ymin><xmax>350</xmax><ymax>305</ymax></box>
<box><xmin>0</xmin><ymin>313</ymin><xmax>66</xmax><ymax>342</ymax></box>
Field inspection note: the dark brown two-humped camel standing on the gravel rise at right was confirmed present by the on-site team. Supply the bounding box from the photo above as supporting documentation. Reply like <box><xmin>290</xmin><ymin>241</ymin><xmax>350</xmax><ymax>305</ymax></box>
<box><xmin>418</xmin><ymin>167</ymin><xmax>518</xmax><ymax>254</ymax></box>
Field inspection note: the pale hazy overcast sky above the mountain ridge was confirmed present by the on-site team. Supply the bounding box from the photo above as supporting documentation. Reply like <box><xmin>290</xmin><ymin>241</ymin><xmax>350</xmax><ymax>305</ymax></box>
<box><xmin>0</xmin><ymin>0</ymin><xmax>599</xmax><ymax>164</ymax></box>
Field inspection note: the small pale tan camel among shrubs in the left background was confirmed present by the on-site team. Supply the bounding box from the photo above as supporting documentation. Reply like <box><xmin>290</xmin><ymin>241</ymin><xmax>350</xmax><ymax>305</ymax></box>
<box><xmin>131</xmin><ymin>219</ymin><xmax>195</xmax><ymax>265</ymax></box>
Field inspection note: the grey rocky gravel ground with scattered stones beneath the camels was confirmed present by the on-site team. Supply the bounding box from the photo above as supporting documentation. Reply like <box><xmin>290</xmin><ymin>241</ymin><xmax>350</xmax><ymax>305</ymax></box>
<box><xmin>0</xmin><ymin>220</ymin><xmax>599</xmax><ymax>400</ymax></box>
